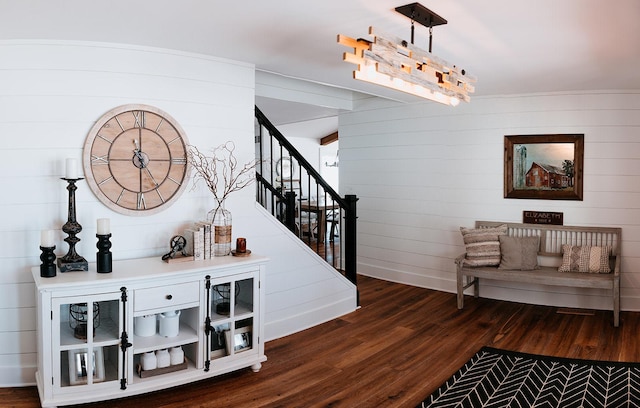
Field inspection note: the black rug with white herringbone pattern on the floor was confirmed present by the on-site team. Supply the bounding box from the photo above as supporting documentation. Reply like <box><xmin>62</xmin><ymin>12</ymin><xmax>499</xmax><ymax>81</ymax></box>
<box><xmin>418</xmin><ymin>347</ymin><xmax>640</xmax><ymax>408</ymax></box>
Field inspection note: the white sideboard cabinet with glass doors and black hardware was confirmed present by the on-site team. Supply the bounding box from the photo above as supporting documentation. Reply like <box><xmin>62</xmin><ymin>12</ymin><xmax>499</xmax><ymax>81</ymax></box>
<box><xmin>32</xmin><ymin>255</ymin><xmax>268</xmax><ymax>407</ymax></box>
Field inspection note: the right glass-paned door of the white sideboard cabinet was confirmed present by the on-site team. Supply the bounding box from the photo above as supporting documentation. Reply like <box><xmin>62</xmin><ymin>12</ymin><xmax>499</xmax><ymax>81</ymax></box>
<box><xmin>206</xmin><ymin>274</ymin><xmax>258</xmax><ymax>364</ymax></box>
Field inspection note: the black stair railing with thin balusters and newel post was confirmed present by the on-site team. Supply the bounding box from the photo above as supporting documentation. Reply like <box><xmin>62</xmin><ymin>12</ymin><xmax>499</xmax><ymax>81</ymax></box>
<box><xmin>255</xmin><ymin>106</ymin><xmax>358</xmax><ymax>302</ymax></box>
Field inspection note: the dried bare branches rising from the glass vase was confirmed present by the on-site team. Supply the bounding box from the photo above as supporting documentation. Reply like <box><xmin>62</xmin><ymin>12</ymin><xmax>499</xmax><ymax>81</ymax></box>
<box><xmin>189</xmin><ymin>141</ymin><xmax>256</xmax><ymax>208</ymax></box>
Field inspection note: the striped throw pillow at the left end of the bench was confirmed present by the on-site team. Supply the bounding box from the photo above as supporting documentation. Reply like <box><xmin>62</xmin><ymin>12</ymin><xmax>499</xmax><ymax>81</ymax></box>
<box><xmin>460</xmin><ymin>224</ymin><xmax>507</xmax><ymax>266</ymax></box>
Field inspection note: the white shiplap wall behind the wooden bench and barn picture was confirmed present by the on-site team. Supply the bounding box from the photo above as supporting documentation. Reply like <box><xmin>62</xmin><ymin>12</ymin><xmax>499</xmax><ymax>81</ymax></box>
<box><xmin>339</xmin><ymin>91</ymin><xmax>640</xmax><ymax>310</ymax></box>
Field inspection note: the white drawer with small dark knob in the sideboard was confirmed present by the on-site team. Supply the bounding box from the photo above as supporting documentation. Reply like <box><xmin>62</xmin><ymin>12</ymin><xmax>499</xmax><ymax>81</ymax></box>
<box><xmin>133</xmin><ymin>282</ymin><xmax>200</xmax><ymax>312</ymax></box>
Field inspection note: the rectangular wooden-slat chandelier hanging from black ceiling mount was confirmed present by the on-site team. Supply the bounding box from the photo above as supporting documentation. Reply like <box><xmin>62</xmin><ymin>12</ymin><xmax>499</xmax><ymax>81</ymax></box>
<box><xmin>338</xmin><ymin>3</ymin><xmax>476</xmax><ymax>106</ymax></box>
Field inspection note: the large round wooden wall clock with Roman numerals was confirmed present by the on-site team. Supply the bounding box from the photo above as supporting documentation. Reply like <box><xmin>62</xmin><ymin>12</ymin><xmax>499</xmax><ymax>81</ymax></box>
<box><xmin>82</xmin><ymin>104</ymin><xmax>189</xmax><ymax>215</ymax></box>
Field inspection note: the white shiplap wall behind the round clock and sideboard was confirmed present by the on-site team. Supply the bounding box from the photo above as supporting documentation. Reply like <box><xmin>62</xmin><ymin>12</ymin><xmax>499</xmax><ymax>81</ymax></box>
<box><xmin>0</xmin><ymin>41</ymin><xmax>355</xmax><ymax>386</ymax></box>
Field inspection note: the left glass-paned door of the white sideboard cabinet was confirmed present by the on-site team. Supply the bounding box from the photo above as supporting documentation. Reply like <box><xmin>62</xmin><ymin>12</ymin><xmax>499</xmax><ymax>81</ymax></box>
<box><xmin>51</xmin><ymin>292</ymin><xmax>125</xmax><ymax>391</ymax></box>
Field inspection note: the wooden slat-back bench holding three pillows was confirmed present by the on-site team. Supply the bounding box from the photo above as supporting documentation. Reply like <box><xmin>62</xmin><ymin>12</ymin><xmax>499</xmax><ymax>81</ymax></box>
<box><xmin>455</xmin><ymin>221</ymin><xmax>622</xmax><ymax>327</ymax></box>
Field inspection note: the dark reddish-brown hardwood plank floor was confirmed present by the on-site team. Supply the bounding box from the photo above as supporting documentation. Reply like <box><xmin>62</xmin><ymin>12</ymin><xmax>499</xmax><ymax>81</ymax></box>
<box><xmin>0</xmin><ymin>276</ymin><xmax>640</xmax><ymax>408</ymax></box>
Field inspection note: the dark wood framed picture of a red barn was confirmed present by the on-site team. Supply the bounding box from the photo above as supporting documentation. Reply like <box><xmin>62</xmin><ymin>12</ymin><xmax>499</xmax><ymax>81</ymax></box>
<box><xmin>504</xmin><ymin>134</ymin><xmax>584</xmax><ymax>201</ymax></box>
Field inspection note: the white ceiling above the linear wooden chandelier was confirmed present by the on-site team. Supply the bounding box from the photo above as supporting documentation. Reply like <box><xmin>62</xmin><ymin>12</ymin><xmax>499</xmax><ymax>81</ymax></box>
<box><xmin>0</xmin><ymin>0</ymin><xmax>640</xmax><ymax>129</ymax></box>
